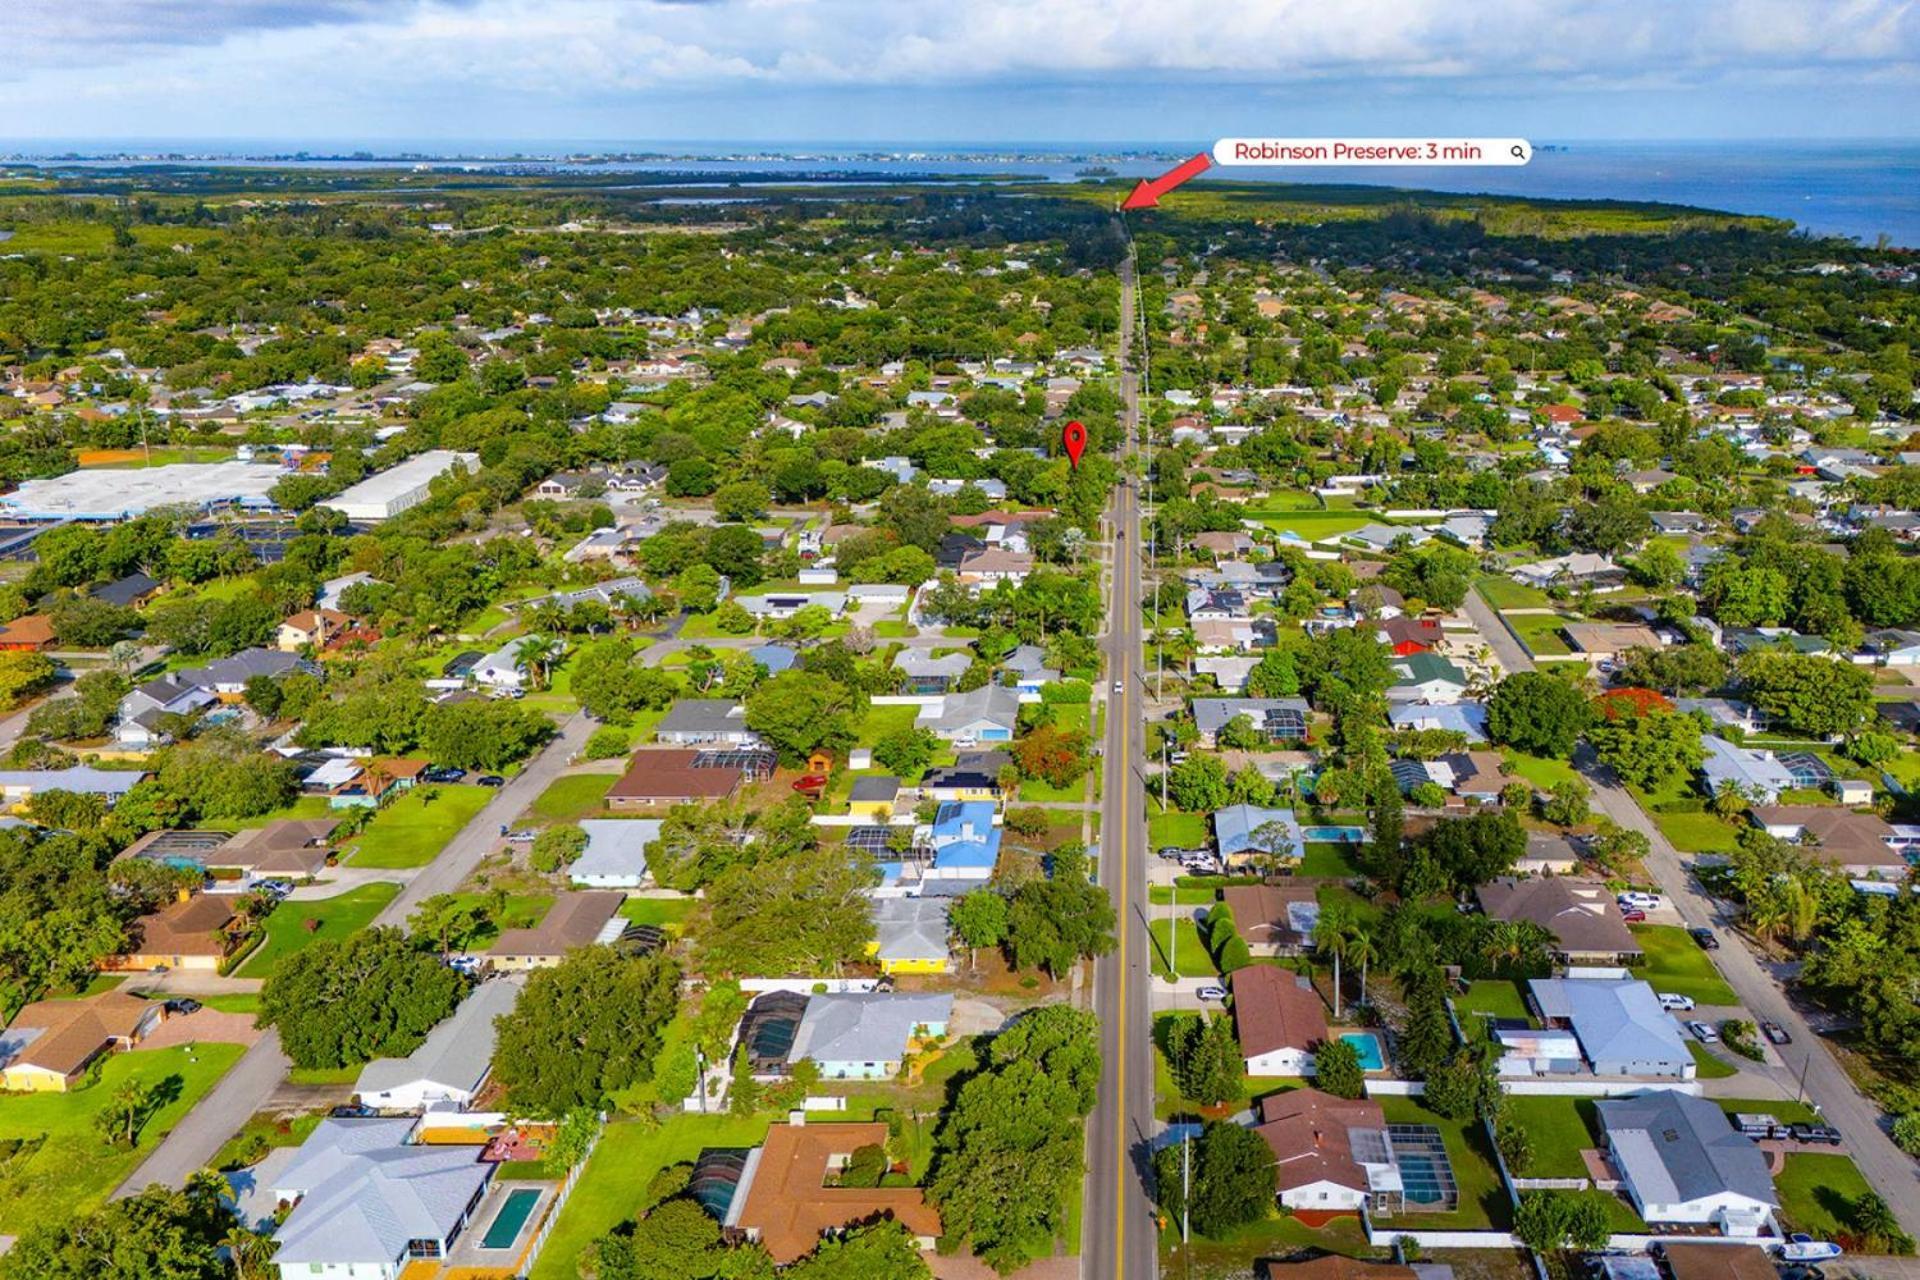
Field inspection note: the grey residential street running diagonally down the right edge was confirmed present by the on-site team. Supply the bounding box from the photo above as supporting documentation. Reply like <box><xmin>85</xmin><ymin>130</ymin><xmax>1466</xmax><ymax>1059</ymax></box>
<box><xmin>1574</xmin><ymin>747</ymin><xmax>1920</xmax><ymax>1236</ymax></box>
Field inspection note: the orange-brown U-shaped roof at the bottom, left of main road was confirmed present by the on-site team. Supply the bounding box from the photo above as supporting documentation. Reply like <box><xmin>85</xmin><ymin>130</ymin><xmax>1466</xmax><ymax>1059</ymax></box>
<box><xmin>739</xmin><ymin>1123</ymin><xmax>941</xmax><ymax>1267</ymax></box>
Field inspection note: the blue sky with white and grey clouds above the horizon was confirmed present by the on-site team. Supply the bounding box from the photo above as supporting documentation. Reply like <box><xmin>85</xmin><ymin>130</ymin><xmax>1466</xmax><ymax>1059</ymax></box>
<box><xmin>0</xmin><ymin>0</ymin><xmax>1920</xmax><ymax>146</ymax></box>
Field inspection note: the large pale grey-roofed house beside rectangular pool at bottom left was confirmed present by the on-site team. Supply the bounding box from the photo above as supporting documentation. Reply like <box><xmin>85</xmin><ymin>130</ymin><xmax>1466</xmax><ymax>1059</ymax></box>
<box><xmin>271</xmin><ymin>1117</ymin><xmax>493</xmax><ymax>1280</ymax></box>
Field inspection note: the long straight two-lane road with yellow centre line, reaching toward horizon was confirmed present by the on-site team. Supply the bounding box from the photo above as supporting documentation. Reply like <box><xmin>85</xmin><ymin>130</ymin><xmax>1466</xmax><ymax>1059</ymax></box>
<box><xmin>1081</xmin><ymin>237</ymin><xmax>1158</xmax><ymax>1280</ymax></box>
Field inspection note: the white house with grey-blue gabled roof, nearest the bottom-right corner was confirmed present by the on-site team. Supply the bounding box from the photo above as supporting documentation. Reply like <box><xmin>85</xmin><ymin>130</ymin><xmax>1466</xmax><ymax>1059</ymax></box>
<box><xmin>1594</xmin><ymin>1088</ymin><xmax>1780</xmax><ymax>1236</ymax></box>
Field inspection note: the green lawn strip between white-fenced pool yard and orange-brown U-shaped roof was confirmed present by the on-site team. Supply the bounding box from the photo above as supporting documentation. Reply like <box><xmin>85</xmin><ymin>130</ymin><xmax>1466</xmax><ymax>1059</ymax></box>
<box><xmin>530</xmin><ymin>1115</ymin><xmax>772</xmax><ymax>1280</ymax></box>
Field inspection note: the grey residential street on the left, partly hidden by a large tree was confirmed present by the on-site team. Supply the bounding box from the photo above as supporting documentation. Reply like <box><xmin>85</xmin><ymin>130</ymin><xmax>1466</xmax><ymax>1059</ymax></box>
<box><xmin>113</xmin><ymin>714</ymin><xmax>593</xmax><ymax>1197</ymax></box>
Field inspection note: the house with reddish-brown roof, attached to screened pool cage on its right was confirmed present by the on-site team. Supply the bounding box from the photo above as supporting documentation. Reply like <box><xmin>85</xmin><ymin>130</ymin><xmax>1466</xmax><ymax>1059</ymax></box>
<box><xmin>1254</xmin><ymin>1088</ymin><xmax>1398</xmax><ymax>1224</ymax></box>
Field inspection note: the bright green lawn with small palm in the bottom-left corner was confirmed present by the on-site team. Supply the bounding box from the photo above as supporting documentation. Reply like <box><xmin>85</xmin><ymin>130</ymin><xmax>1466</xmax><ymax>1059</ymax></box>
<box><xmin>0</xmin><ymin>1044</ymin><xmax>244</xmax><ymax>1236</ymax></box>
